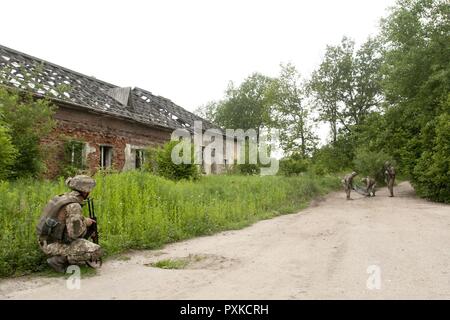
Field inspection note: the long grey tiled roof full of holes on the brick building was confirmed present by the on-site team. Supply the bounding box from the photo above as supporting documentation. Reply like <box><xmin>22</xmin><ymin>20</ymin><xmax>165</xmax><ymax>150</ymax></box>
<box><xmin>0</xmin><ymin>45</ymin><xmax>218</xmax><ymax>131</ymax></box>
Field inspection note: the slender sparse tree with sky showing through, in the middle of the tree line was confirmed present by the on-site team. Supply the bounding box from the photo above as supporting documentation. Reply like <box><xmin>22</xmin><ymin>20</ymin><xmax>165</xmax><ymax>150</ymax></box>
<box><xmin>272</xmin><ymin>64</ymin><xmax>318</xmax><ymax>158</ymax></box>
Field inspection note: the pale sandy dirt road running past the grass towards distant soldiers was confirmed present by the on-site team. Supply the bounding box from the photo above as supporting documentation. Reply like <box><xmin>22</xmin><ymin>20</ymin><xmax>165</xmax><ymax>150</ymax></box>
<box><xmin>0</xmin><ymin>182</ymin><xmax>450</xmax><ymax>299</ymax></box>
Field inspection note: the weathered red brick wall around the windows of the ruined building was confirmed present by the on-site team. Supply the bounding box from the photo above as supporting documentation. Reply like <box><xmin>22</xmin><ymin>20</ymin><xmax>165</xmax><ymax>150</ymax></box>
<box><xmin>42</xmin><ymin>106</ymin><xmax>171</xmax><ymax>178</ymax></box>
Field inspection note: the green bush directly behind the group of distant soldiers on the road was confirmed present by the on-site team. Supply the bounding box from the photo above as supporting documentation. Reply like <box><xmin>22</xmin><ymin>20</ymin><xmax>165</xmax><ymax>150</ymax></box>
<box><xmin>353</xmin><ymin>147</ymin><xmax>395</xmax><ymax>185</ymax></box>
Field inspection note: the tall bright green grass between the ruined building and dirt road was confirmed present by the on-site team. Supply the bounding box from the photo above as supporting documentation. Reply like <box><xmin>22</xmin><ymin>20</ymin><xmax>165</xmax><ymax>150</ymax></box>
<box><xmin>0</xmin><ymin>171</ymin><xmax>340</xmax><ymax>277</ymax></box>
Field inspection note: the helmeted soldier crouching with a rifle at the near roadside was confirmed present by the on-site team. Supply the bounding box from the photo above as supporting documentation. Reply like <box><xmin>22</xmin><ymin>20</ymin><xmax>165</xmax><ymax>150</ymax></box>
<box><xmin>36</xmin><ymin>176</ymin><xmax>102</xmax><ymax>272</ymax></box>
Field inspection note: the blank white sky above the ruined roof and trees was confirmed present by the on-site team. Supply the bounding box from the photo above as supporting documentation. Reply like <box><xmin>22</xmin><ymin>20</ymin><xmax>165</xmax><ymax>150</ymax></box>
<box><xmin>0</xmin><ymin>0</ymin><xmax>394</xmax><ymax>142</ymax></box>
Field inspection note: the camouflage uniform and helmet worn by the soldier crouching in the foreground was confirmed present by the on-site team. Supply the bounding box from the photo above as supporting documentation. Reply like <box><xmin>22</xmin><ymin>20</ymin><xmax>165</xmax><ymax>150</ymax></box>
<box><xmin>38</xmin><ymin>176</ymin><xmax>102</xmax><ymax>272</ymax></box>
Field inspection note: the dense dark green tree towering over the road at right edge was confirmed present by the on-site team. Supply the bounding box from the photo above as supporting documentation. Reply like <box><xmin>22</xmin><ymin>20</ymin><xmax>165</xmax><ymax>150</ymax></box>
<box><xmin>382</xmin><ymin>0</ymin><xmax>450</xmax><ymax>201</ymax></box>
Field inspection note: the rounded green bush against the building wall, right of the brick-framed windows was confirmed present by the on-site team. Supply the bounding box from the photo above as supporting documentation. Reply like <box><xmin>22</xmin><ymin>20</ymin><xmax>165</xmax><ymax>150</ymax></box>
<box><xmin>144</xmin><ymin>141</ymin><xmax>199</xmax><ymax>180</ymax></box>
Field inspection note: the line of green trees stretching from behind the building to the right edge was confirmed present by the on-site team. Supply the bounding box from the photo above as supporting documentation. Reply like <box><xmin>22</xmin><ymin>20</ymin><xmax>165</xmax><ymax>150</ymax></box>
<box><xmin>196</xmin><ymin>0</ymin><xmax>450</xmax><ymax>202</ymax></box>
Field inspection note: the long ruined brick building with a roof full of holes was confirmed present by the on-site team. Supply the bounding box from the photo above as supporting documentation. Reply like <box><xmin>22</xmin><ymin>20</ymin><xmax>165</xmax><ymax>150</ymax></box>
<box><xmin>0</xmin><ymin>46</ymin><xmax>225</xmax><ymax>177</ymax></box>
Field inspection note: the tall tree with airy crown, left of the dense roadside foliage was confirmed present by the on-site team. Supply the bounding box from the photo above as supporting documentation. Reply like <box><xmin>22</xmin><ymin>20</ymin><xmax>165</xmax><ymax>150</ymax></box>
<box><xmin>308</xmin><ymin>37</ymin><xmax>382</xmax><ymax>142</ymax></box>
